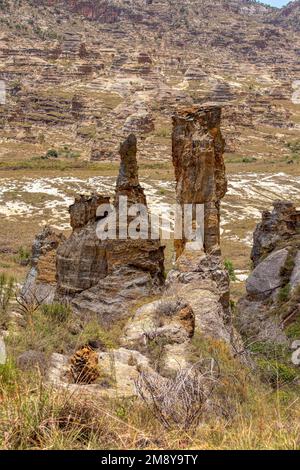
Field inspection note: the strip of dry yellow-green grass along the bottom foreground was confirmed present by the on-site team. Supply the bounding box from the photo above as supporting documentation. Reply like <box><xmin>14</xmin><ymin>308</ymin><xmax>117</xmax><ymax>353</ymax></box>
<box><xmin>0</xmin><ymin>363</ymin><xmax>300</xmax><ymax>450</ymax></box>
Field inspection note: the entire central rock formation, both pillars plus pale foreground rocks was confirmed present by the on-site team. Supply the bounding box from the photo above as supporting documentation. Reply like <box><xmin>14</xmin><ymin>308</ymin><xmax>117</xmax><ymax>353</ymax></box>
<box><xmin>24</xmin><ymin>105</ymin><xmax>240</xmax><ymax>395</ymax></box>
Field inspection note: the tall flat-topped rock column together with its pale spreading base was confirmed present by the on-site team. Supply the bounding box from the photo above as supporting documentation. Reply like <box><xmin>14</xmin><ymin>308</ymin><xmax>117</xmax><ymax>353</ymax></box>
<box><xmin>122</xmin><ymin>106</ymin><xmax>239</xmax><ymax>374</ymax></box>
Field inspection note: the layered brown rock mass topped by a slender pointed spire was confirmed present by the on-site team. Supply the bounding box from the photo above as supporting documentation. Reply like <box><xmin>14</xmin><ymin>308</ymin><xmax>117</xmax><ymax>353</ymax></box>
<box><xmin>57</xmin><ymin>135</ymin><xmax>164</xmax><ymax>323</ymax></box>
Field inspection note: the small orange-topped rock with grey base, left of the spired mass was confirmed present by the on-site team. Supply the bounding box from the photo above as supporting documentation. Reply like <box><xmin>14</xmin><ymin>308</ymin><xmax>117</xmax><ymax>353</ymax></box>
<box><xmin>22</xmin><ymin>226</ymin><xmax>65</xmax><ymax>303</ymax></box>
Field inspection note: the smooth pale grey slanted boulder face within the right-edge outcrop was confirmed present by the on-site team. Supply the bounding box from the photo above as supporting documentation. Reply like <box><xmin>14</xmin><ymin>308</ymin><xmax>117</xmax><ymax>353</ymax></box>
<box><xmin>246</xmin><ymin>249</ymin><xmax>288</xmax><ymax>297</ymax></box>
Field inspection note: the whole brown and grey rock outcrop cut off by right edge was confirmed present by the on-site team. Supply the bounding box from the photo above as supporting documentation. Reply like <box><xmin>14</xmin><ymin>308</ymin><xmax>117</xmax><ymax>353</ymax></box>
<box><xmin>238</xmin><ymin>201</ymin><xmax>300</xmax><ymax>344</ymax></box>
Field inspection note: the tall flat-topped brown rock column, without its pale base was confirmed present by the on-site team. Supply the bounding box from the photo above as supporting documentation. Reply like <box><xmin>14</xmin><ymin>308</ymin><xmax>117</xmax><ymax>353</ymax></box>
<box><xmin>172</xmin><ymin>105</ymin><xmax>227</xmax><ymax>257</ymax></box>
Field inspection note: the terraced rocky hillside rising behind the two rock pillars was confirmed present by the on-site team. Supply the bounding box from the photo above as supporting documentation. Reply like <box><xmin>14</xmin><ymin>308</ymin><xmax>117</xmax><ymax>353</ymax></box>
<box><xmin>0</xmin><ymin>0</ymin><xmax>300</xmax><ymax>162</ymax></box>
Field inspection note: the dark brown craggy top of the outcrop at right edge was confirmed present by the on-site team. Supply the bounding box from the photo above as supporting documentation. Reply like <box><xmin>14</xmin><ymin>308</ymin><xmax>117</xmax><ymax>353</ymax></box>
<box><xmin>251</xmin><ymin>201</ymin><xmax>300</xmax><ymax>267</ymax></box>
